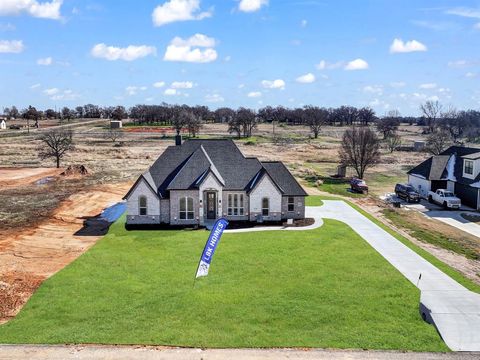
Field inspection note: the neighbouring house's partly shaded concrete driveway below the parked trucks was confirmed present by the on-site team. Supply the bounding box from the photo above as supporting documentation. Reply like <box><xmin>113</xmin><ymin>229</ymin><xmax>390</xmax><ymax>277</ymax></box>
<box><xmin>402</xmin><ymin>200</ymin><xmax>480</xmax><ymax>238</ymax></box>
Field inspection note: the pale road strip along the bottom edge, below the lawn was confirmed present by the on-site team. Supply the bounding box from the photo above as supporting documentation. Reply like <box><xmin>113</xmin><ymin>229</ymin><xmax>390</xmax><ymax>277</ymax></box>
<box><xmin>0</xmin><ymin>345</ymin><xmax>480</xmax><ymax>360</ymax></box>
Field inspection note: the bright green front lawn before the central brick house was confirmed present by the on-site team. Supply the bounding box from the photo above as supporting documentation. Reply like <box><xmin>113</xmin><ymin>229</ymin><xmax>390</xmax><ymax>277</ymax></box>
<box><xmin>0</xmin><ymin>215</ymin><xmax>447</xmax><ymax>351</ymax></box>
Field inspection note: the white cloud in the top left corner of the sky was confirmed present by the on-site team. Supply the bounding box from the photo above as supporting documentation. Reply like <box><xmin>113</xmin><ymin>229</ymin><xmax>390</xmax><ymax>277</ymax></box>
<box><xmin>0</xmin><ymin>0</ymin><xmax>63</xmax><ymax>20</ymax></box>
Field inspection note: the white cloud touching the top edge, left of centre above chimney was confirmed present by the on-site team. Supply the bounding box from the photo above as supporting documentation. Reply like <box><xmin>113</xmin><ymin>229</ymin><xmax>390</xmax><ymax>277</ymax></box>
<box><xmin>152</xmin><ymin>0</ymin><xmax>212</xmax><ymax>26</ymax></box>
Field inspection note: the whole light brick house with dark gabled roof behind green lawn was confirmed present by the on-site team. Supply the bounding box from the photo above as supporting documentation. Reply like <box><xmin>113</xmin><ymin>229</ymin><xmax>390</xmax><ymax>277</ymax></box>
<box><xmin>124</xmin><ymin>136</ymin><xmax>307</xmax><ymax>226</ymax></box>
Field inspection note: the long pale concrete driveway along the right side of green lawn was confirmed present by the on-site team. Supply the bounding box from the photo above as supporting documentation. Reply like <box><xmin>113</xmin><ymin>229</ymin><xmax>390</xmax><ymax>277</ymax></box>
<box><xmin>315</xmin><ymin>200</ymin><xmax>480</xmax><ymax>351</ymax></box>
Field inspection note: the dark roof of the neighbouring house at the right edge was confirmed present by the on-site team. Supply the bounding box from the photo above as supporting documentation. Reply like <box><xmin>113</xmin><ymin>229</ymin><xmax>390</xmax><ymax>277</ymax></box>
<box><xmin>408</xmin><ymin>146</ymin><xmax>480</xmax><ymax>185</ymax></box>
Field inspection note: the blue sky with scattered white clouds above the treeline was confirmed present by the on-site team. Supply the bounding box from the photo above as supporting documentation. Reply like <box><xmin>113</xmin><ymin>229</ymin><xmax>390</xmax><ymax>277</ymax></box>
<box><xmin>0</xmin><ymin>0</ymin><xmax>480</xmax><ymax>115</ymax></box>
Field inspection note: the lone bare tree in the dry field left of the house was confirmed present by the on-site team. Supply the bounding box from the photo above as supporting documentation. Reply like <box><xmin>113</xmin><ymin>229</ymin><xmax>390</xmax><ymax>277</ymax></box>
<box><xmin>38</xmin><ymin>130</ymin><xmax>74</xmax><ymax>168</ymax></box>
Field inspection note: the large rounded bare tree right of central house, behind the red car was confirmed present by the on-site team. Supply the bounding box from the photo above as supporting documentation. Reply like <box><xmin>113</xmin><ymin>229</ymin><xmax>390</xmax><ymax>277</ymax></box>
<box><xmin>339</xmin><ymin>127</ymin><xmax>380</xmax><ymax>178</ymax></box>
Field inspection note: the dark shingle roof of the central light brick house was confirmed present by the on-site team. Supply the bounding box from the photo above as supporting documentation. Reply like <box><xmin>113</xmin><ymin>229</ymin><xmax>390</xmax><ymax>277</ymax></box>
<box><xmin>137</xmin><ymin>139</ymin><xmax>306</xmax><ymax>197</ymax></box>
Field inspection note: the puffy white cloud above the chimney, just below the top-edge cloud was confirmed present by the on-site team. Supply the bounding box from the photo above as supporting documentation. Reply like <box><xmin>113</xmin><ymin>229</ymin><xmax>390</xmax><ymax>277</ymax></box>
<box><xmin>163</xmin><ymin>34</ymin><xmax>218</xmax><ymax>63</ymax></box>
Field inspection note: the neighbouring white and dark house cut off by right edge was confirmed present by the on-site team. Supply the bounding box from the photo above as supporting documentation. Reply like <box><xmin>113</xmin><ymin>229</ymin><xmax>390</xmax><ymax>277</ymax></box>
<box><xmin>408</xmin><ymin>146</ymin><xmax>480</xmax><ymax>210</ymax></box>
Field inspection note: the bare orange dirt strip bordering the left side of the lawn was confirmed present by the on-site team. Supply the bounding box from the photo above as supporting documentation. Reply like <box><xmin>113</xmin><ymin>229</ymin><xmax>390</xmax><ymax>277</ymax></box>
<box><xmin>0</xmin><ymin>183</ymin><xmax>130</xmax><ymax>323</ymax></box>
